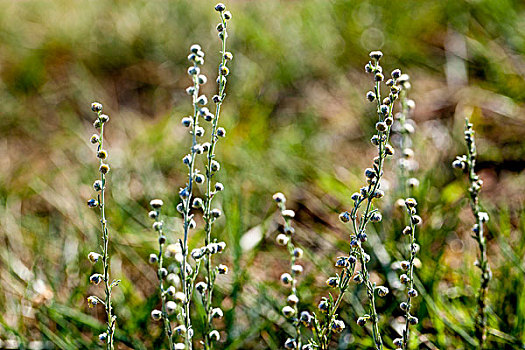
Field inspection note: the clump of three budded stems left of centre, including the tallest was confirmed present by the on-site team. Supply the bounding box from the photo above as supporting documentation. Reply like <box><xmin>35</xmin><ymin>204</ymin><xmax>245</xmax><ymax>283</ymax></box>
<box><xmin>145</xmin><ymin>3</ymin><xmax>233</xmax><ymax>349</ymax></box>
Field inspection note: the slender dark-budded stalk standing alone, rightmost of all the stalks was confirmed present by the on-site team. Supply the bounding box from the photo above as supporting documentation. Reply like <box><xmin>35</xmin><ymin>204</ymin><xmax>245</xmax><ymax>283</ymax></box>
<box><xmin>452</xmin><ymin>119</ymin><xmax>492</xmax><ymax>349</ymax></box>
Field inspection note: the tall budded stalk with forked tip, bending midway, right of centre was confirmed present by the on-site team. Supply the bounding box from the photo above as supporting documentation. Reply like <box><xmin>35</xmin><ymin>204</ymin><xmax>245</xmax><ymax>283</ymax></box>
<box><xmin>339</xmin><ymin>51</ymin><xmax>408</xmax><ymax>350</ymax></box>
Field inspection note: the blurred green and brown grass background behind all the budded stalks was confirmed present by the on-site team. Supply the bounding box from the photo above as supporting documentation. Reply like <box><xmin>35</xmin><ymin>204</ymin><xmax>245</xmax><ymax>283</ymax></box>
<box><xmin>0</xmin><ymin>0</ymin><xmax>525</xmax><ymax>349</ymax></box>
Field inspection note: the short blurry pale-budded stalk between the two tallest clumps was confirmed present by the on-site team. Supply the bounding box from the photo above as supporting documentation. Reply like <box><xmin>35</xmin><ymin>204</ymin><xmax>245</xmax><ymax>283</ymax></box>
<box><xmin>273</xmin><ymin>192</ymin><xmax>304</xmax><ymax>349</ymax></box>
